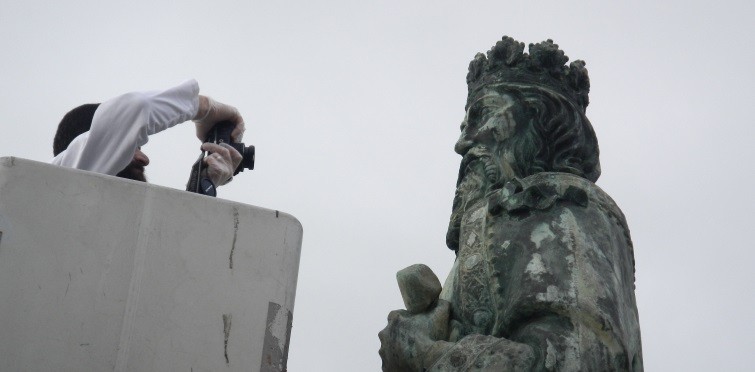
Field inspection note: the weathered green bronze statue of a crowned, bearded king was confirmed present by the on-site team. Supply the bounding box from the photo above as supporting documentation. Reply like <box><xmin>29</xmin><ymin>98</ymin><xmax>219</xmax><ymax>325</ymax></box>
<box><xmin>379</xmin><ymin>37</ymin><xmax>643</xmax><ymax>371</ymax></box>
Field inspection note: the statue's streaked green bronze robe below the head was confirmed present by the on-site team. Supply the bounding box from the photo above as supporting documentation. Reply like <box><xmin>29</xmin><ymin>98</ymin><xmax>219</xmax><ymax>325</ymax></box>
<box><xmin>429</xmin><ymin>173</ymin><xmax>643</xmax><ymax>371</ymax></box>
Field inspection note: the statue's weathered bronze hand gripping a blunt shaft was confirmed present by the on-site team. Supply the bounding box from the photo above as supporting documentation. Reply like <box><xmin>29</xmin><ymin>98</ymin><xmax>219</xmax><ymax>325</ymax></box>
<box><xmin>378</xmin><ymin>300</ymin><xmax>451</xmax><ymax>372</ymax></box>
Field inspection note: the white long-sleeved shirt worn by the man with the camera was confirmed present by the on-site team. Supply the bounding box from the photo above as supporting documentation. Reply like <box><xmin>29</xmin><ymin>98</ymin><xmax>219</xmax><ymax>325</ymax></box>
<box><xmin>52</xmin><ymin>80</ymin><xmax>199</xmax><ymax>175</ymax></box>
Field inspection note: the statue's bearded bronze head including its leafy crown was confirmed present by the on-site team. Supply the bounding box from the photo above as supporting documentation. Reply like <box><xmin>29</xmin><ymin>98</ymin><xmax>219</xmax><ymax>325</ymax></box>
<box><xmin>447</xmin><ymin>37</ymin><xmax>600</xmax><ymax>250</ymax></box>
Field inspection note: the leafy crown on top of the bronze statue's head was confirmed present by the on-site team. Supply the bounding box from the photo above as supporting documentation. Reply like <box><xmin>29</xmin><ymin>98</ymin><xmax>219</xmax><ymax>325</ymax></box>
<box><xmin>467</xmin><ymin>36</ymin><xmax>590</xmax><ymax>112</ymax></box>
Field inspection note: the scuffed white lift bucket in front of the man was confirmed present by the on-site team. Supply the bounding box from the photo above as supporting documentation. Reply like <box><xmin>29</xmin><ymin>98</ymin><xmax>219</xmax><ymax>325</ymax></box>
<box><xmin>0</xmin><ymin>157</ymin><xmax>302</xmax><ymax>372</ymax></box>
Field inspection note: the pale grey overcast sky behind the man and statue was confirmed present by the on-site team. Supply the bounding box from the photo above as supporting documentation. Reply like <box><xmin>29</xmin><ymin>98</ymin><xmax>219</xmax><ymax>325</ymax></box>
<box><xmin>0</xmin><ymin>0</ymin><xmax>755</xmax><ymax>371</ymax></box>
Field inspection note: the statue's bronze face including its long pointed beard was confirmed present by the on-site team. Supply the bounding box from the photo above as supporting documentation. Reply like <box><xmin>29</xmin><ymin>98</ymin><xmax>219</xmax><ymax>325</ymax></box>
<box><xmin>446</xmin><ymin>89</ymin><xmax>517</xmax><ymax>249</ymax></box>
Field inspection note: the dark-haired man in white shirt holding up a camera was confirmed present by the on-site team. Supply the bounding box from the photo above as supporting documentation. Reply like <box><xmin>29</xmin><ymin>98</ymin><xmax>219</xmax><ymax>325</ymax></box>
<box><xmin>52</xmin><ymin>80</ymin><xmax>244</xmax><ymax>185</ymax></box>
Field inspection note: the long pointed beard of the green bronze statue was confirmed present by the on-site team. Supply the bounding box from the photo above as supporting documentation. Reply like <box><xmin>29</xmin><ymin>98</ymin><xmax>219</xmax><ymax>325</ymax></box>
<box><xmin>446</xmin><ymin>145</ymin><xmax>504</xmax><ymax>251</ymax></box>
